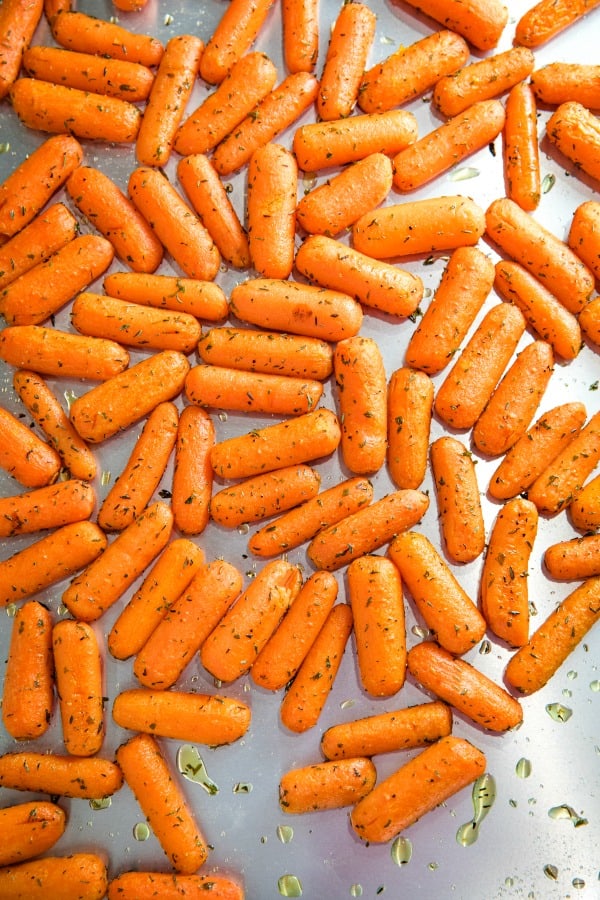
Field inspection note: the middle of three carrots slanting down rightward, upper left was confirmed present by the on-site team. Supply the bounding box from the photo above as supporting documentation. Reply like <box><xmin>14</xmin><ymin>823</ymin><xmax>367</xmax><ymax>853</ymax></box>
<box><xmin>129</xmin><ymin>166</ymin><xmax>221</xmax><ymax>281</ymax></box>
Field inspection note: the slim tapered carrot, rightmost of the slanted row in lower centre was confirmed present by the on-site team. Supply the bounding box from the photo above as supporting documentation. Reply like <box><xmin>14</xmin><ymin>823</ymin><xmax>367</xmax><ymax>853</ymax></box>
<box><xmin>279</xmin><ymin>603</ymin><xmax>353</xmax><ymax>734</ymax></box>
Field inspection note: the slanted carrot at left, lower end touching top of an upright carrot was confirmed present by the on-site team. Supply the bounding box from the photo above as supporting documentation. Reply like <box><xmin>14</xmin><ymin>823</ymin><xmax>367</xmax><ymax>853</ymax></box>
<box><xmin>62</xmin><ymin>501</ymin><xmax>173</xmax><ymax>622</ymax></box>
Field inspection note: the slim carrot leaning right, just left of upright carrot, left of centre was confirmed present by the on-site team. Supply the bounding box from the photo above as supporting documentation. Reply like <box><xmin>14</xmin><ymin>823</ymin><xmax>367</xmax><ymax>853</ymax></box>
<box><xmin>98</xmin><ymin>401</ymin><xmax>179</xmax><ymax>531</ymax></box>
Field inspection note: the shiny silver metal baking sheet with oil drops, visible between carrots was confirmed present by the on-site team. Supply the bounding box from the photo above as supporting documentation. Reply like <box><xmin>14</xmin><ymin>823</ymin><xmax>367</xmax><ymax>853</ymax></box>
<box><xmin>0</xmin><ymin>0</ymin><xmax>600</xmax><ymax>900</ymax></box>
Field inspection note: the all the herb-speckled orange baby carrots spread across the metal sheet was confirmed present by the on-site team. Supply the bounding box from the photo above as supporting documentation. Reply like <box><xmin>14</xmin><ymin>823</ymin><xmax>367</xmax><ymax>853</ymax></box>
<box><xmin>0</xmin><ymin>0</ymin><xmax>600</xmax><ymax>900</ymax></box>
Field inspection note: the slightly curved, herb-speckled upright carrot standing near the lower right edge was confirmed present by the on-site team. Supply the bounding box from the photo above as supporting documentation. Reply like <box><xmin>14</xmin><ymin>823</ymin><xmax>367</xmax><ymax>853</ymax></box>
<box><xmin>479</xmin><ymin>497</ymin><xmax>538</xmax><ymax>647</ymax></box>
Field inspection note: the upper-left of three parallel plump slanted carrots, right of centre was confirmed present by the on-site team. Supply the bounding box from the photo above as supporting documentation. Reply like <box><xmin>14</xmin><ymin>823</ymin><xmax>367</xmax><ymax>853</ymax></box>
<box><xmin>406</xmin><ymin>247</ymin><xmax>494</xmax><ymax>375</ymax></box>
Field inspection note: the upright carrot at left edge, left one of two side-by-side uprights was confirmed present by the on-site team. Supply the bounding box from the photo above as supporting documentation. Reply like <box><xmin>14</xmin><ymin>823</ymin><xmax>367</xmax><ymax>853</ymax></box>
<box><xmin>2</xmin><ymin>600</ymin><xmax>54</xmax><ymax>740</ymax></box>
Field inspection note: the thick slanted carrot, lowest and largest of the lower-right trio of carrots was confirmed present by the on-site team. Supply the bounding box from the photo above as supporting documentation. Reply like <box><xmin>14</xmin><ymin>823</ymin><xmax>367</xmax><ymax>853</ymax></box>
<box><xmin>350</xmin><ymin>735</ymin><xmax>486</xmax><ymax>843</ymax></box>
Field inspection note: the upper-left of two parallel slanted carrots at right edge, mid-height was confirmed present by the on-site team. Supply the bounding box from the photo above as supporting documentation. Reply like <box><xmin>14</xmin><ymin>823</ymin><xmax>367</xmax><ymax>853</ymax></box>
<box><xmin>488</xmin><ymin>401</ymin><xmax>587</xmax><ymax>500</ymax></box>
